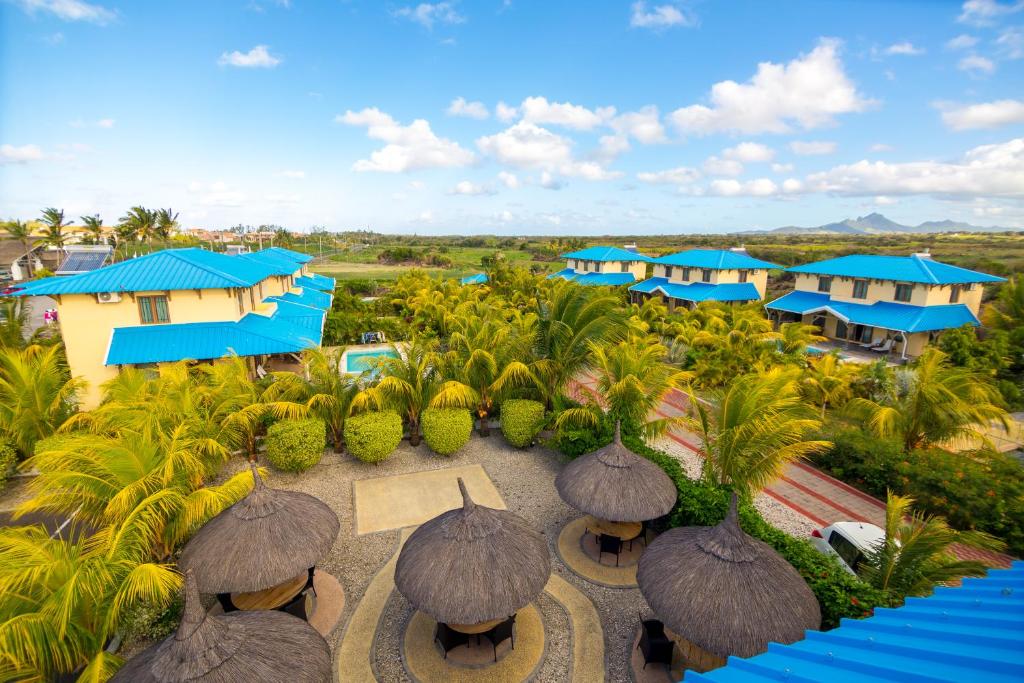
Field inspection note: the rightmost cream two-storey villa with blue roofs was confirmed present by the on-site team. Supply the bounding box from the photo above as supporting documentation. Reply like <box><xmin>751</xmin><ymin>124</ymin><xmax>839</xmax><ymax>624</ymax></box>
<box><xmin>765</xmin><ymin>252</ymin><xmax>1004</xmax><ymax>358</ymax></box>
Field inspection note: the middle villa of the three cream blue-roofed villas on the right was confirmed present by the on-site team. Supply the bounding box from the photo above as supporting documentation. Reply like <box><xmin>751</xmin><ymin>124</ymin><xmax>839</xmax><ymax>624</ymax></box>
<box><xmin>630</xmin><ymin>247</ymin><xmax>782</xmax><ymax>310</ymax></box>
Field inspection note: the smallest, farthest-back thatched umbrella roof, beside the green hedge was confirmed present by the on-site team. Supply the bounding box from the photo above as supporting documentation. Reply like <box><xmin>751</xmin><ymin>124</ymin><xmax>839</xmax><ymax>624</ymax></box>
<box><xmin>555</xmin><ymin>423</ymin><xmax>677</xmax><ymax>522</ymax></box>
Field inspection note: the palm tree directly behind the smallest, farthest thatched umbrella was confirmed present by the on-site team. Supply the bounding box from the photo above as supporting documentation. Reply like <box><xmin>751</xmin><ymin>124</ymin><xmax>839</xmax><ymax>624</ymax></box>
<box><xmin>556</xmin><ymin>337</ymin><xmax>692</xmax><ymax>438</ymax></box>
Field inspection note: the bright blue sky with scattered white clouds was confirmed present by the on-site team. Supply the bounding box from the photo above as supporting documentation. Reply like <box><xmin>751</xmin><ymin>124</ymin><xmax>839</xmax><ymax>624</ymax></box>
<box><xmin>0</xmin><ymin>0</ymin><xmax>1024</xmax><ymax>234</ymax></box>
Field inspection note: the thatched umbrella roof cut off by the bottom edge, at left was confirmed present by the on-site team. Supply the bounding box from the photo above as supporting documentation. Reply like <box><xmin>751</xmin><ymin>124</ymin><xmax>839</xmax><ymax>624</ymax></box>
<box><xmin>112</xmin><ymin>572</ymin><xmax>331</xmax><ymax>683</ymax></box>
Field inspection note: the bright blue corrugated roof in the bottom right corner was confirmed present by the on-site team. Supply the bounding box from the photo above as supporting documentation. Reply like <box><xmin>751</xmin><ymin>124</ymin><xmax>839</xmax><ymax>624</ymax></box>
<box><xmin>683</xmin><ymin>560</ymin><xmax>1024</xmax><ymax>683</ymax></box>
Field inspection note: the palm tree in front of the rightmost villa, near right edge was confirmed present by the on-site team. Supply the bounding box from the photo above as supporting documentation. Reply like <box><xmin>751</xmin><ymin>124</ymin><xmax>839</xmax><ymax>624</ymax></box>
<box><xmin>847</xmin><ymin>346</ymin><xmax>1010</xmax><ymax>453</ymax></box>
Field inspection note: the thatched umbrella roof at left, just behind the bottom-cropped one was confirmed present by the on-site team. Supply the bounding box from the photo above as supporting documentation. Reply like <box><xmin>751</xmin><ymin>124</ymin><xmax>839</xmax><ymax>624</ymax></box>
<box><xmin>178</xmin><ymin>465</ymin><xmax>340</xmax><ymax>593</ymax></box>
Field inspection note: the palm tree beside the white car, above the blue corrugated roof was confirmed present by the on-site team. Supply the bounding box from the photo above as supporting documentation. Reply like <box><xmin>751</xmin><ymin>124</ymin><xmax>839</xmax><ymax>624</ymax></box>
<box><xmin>857</xmin><ymin>492</ymin><xmax>1006</xmax><ymax>600</ymax></box>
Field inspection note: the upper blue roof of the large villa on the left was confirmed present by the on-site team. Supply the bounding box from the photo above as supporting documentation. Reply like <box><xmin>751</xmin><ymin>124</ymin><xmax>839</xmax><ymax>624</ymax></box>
<box><xmin>17</xmin><ymin>248</ymin><xmax>274</xmax><ymax>296</ymax></box>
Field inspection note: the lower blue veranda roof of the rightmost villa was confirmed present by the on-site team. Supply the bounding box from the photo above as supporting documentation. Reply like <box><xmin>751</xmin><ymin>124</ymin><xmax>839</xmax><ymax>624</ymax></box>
<box><xmin>765</xmin><ymin>290</ymin><xmax>979</xmax><ymax>333</ymax></box>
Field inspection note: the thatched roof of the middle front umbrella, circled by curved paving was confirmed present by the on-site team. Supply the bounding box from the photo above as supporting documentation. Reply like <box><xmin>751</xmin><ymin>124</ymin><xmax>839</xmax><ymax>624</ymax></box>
<box><xmin>394</xmin><ymin>478</ymin><xmax>551</xmax><ymax>624</ymax></box>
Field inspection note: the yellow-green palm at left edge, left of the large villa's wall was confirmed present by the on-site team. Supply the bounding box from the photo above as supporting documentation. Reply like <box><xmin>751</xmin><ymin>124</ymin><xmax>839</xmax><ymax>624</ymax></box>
<box><xmin>0</xmin><ymin>345</ymin><xmax>84</xmax><ymax>456</ymax></box>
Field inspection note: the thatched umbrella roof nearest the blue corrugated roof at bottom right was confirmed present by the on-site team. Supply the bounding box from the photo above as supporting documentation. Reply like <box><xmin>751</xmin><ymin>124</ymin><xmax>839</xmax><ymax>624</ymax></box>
<box><xmin>637</xmin><ymin>496</ymin><xmax>821</xmax><ymax>657</ymax></box>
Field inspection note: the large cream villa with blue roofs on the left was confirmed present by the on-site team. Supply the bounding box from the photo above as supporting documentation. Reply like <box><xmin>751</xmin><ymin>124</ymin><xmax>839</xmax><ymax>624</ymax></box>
<box><xmin>16</xmin><ymin>248</ymin><xmax>334</xmax><ymax>409</ymax></box>
